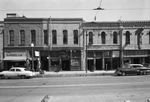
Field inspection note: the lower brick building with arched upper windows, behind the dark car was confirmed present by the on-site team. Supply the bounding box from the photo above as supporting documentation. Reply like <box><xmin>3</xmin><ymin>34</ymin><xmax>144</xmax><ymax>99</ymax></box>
<box><xmin>82</xmin><ymin>21</ymin><xmax>150</xmax><ymax>70</ymax></box>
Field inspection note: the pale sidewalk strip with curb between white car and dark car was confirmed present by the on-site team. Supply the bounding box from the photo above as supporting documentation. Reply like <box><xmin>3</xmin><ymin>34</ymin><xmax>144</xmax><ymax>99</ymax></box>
<box><xmin>36</xmin><ymin>70</ymin><xmax>115</xmax><ymax>77</ymax></box>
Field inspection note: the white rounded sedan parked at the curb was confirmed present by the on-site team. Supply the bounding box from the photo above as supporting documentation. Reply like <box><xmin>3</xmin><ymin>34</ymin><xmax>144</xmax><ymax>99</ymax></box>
<box><xmin>0</xmin><ymin>67</ymin><xmax>34</xmax><ymax>79</ymax></box>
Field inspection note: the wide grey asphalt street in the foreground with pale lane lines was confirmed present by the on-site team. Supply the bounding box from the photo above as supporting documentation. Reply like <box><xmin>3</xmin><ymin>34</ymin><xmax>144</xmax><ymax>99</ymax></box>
<box><xmin>0</xmin><ymin>75</ymin><xmax>150</xmax><ymax>102</ymax></box>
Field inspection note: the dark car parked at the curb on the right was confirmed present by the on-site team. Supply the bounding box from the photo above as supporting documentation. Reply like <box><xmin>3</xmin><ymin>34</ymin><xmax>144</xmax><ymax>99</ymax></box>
<box><xmin>115</xmin><ymin>64</ymin><xmax>150</xmax><ymax>76</ymax></box>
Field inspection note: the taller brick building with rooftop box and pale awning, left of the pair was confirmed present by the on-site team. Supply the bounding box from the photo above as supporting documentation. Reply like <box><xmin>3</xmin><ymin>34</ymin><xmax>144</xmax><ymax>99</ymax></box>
<box><xmin>3</xmin><ymin>14</ymin><xmax>83</xmax><ymax>71</ymax></box>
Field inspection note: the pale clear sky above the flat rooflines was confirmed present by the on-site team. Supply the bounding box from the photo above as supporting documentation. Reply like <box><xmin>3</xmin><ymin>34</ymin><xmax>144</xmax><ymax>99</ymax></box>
<box><xmin>0</xmin><ymin>0</ymin><xmax>150</xmax><ymax>21</ymax></box>
